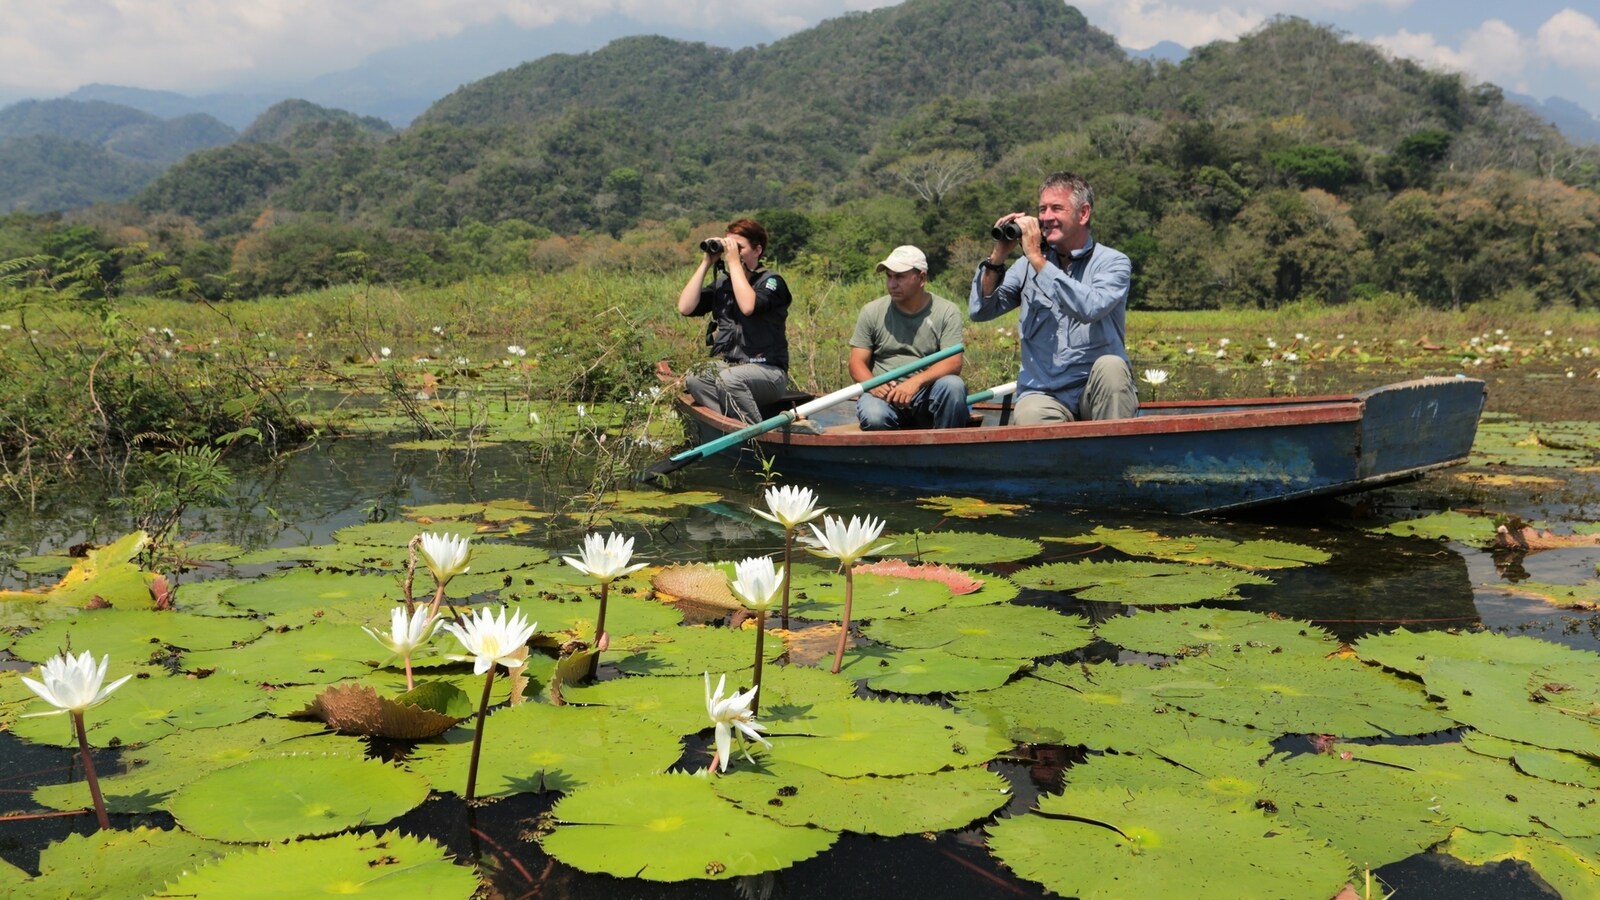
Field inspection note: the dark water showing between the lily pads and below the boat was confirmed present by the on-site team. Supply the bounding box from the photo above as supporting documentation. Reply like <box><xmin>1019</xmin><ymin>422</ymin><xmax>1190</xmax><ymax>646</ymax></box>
<box><xmin>0</xmin><ymin>440</ymin><xmax>1600</xmax><ymax>898</ymax></box>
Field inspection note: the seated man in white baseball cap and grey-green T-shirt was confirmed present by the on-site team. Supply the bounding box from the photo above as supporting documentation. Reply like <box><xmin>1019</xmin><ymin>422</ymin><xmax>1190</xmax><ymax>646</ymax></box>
<box><xmin>850</xmin><ymin>245</ymin><xmax>968</xmax><ymax>431</ymax></box>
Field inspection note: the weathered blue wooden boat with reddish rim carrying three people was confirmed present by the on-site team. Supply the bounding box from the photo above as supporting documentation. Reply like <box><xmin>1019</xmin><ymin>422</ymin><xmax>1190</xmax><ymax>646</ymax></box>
<box><xmin>662</xmin><ymin>371</ymin><xmax>1486</xmax><ymax>514</ymax></box>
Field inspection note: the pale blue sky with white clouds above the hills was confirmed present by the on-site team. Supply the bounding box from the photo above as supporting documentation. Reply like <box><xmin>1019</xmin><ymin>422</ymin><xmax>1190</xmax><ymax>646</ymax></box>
<box><xmin>0</xmin><ymin>0</ymin><xmax>1600</xmax><ymax>114</ymax></box>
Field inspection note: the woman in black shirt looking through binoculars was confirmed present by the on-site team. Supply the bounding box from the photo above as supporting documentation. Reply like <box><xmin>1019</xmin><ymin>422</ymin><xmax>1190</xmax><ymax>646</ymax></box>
<box><xmin>678</xmin><ymin>219</ymin><xmax>790</xmax><ymax>423</ymax></box>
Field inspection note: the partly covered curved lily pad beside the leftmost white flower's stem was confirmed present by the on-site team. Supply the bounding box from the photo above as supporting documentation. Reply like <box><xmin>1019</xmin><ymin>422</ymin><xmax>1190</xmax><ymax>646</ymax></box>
<box><xmin>34</xmin><ymin>717</ymin><xmax>366</xmax><ymax>812</ymax></box>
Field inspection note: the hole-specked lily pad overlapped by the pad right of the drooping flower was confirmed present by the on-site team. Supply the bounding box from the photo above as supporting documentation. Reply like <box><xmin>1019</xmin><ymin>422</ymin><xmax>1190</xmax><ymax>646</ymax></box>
<box><xmin>712</xmin><ymin>759</ymin><xmax>1011</xmax><ymax>838</ymax></box>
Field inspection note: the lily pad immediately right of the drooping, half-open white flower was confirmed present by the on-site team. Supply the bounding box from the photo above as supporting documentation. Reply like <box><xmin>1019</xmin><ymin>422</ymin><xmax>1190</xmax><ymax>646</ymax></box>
<box><xmin>762</xmin><ymin>700</ymin><xmax>1011</xmax><ymax>778</ymax></box>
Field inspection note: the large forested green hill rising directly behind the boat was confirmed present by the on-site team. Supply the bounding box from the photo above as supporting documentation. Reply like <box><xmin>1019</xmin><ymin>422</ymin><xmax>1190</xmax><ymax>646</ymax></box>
<box><xmin>12</xmin><ymin>0</ymin><xmax>1600</xmax><ymax>307</ymax></box>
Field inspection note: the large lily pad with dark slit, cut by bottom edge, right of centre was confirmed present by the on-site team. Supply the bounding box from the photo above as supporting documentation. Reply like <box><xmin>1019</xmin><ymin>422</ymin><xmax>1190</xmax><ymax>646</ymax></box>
<box><xmin>989</xmin><ymin>785</ymin><xmax>1352</xmax><ymax>900</ymax></box>
